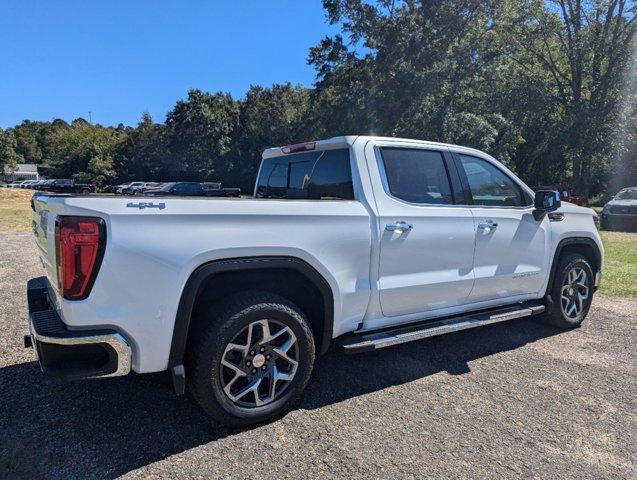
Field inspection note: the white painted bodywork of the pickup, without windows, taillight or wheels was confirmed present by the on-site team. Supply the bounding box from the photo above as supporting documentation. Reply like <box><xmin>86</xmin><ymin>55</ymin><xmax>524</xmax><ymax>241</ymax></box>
<box><xmin>34</xmin><ymin>137</ymin><xmax>602</xmax><ymax>372</ymax></box>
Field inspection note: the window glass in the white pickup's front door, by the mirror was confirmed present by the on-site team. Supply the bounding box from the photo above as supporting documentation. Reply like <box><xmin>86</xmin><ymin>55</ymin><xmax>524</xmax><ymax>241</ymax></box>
<box><xmin>460</xmin><ymin>155</ymin><xmax>527</xmax><ymax>207</ymax></box>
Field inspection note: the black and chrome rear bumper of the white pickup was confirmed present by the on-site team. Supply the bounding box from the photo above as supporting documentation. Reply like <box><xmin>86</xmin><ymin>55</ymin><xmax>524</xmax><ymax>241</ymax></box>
<box><xmin>25</xmin><ymin>277</ymin><xmax>131</xmax><ymax>379</ymax></box>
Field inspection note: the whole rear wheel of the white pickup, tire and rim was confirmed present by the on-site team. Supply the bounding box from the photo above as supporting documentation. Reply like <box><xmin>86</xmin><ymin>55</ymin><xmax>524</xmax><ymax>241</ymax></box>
<box><xmin>187</xmin><ymin>292</ymin><xmax>314</xmax><ymax>426</ymax></box>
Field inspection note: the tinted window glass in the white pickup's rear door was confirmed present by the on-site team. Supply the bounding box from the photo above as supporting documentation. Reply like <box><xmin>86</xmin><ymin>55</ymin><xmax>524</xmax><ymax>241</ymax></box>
<box><xmin>381</xmin><ymin>147</ymin><xmax>453</xmax><ymax>205</ymax></box>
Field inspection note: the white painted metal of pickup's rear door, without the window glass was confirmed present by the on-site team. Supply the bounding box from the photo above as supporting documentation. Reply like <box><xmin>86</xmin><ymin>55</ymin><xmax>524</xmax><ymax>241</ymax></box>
<box><xmin>365</xmin><ymin>141</ymin><xmax>475</xmax><ymax>317</ymax></box>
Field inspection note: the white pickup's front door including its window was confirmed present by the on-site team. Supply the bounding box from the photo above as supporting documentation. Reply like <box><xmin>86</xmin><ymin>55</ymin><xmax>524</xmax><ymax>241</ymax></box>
<box><xmin>454</xmin><ymin>153</ymin><xmax>550</xmax><ymax>303</ymax></box>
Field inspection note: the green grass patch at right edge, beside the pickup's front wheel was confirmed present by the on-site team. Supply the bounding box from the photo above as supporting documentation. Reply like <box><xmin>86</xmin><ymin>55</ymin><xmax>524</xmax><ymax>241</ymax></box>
<box><xmin>600</xmin><ymin>232</ymin><xmax>637</xmax><ymax>298</ymax></box>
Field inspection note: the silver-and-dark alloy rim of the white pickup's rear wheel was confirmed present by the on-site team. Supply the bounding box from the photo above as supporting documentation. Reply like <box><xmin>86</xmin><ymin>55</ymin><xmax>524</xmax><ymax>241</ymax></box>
<box><xmin>219</xmin><ymin>320</ymin><xmax>299</xmax><ymax>408</ymax></box>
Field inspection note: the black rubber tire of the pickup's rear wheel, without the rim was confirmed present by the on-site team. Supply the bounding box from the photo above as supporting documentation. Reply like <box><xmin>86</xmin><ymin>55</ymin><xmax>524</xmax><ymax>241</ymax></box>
<box><xmin>186</xmin><ymin>292</ymin><xmax>315</xmax><ymax>426</ymax></box>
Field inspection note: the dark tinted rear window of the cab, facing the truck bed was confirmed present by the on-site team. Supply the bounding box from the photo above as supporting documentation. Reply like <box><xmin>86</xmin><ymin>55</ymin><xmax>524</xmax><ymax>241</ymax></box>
<box><xmin>256</xmin><ymin>148</ymin><xmax>354</xmax><ymax>200</ymax></box>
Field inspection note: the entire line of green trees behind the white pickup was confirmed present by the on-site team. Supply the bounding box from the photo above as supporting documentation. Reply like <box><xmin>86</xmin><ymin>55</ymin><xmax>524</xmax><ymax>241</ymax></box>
<box><xmin>0</xmin><ymin>0</ymin><xmax>637</xmax><ymax>195</ymax></box>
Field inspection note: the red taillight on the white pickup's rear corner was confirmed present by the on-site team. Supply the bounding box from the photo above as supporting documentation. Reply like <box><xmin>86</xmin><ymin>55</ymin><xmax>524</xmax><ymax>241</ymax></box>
<box><xmin>55</xmin><ymin>216</ymin><xmax>106</xmax><ymax>300</ymax></box>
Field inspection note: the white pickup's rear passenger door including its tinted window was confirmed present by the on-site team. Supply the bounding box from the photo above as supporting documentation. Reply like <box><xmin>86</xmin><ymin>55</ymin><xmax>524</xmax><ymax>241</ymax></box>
<box><xmin>365</xmin><ymin>141</ymin><xmax>475</xmax><ymax>323</ymax></box>
